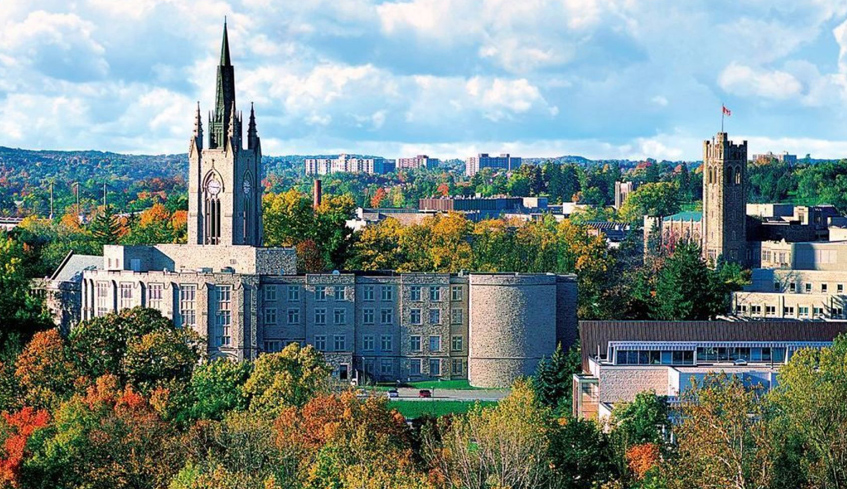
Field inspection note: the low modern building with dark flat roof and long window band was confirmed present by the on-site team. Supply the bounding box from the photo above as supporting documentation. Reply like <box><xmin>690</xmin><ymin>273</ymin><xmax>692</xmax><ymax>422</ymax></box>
<box><xmin>573</xmin><ymin>320</ymin><xmax>847</xmax><ymax>420</ymax></box>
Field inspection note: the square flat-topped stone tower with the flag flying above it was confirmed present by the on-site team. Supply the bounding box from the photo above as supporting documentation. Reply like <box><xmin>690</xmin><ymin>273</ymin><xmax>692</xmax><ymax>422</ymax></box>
<box><xmin>702</xmin><ymin>132</ymin><xmax>747</xmax><ymax>265</ymax></box>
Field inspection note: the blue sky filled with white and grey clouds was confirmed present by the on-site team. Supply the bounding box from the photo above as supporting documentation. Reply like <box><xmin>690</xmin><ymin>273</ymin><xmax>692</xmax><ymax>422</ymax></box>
<box><xmin>0</xmin><ymin>0</ymin><xmax>847</xmax><ymax>160</ymax></box>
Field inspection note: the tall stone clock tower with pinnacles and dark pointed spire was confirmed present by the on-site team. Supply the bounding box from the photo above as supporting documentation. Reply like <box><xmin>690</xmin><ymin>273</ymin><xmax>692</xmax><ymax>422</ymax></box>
<box><xmin>188</xmin><ymin>22</ymin><xmax>262</xmax><ymax>246</ymax></box>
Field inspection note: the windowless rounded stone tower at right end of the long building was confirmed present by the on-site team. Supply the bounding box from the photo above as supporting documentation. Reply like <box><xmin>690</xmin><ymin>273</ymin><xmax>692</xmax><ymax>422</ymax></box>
<box><xmin>468</xmin><ymin>274</ymin><xmax>557</xmax><ymax>387</ymax></box>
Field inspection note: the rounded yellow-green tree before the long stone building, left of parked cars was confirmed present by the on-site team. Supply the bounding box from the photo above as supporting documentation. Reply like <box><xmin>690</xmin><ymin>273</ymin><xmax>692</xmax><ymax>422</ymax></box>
<box><xmin>244</xmin><ymin>343</ymin><xmax>332</xmax><ymax>415</ymax></box>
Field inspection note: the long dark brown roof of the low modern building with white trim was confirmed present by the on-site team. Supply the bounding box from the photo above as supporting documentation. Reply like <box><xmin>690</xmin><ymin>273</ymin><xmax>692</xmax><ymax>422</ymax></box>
<box><xmin>579</xmin><ymin>321</ymin><xmax>847</xmax><ymax>370</ymax></box>
